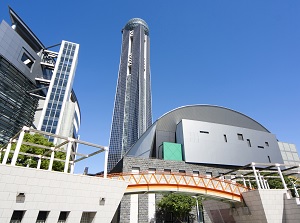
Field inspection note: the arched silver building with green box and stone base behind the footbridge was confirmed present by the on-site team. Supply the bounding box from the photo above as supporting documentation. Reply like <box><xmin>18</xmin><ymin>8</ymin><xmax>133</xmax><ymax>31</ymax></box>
<box><xmin>111</xmin><ymin>105</ymin><xmax>299</xmax><ymax>222</ymax></box>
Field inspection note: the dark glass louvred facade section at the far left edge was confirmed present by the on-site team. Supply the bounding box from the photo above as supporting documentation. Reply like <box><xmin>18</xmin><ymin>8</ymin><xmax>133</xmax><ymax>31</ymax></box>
<box><xmin>0</xmin><ymin>55</ymin><xmax>38</xmax><ymax>144</ymax></box>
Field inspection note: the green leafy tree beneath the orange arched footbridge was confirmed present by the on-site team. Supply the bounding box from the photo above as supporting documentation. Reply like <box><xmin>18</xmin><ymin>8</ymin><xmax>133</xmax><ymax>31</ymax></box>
<box><xmin>157</xmin><ymin>193</ymin><xmax>196</xmax><ymax>222</ymax></box>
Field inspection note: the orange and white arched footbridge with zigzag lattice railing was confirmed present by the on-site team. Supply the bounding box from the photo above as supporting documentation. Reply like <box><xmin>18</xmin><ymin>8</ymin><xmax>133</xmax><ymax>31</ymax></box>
<box><xmin>107</xmin><ymin>173</ymin><xmax>249</xmax><ymax>201</ymax></box>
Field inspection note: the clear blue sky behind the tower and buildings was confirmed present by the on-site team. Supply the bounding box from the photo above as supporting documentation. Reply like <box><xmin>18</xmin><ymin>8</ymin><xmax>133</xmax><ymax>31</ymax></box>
<box><xmin>0</xmin><ymin>0</ymin><xmax>300</xmax><ymax>173</ymax></box>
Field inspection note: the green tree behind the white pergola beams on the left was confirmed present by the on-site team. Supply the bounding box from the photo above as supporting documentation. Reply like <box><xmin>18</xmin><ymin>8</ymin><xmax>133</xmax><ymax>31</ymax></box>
<box><xmin>1</xmin><ymin>133</ymin><xmax>66</xmax><ymax>171</ymax></box>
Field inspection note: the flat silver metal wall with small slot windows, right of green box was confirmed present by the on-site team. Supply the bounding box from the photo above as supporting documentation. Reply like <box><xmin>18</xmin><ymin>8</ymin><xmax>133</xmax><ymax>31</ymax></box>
<box><xmin>176</xmin><ymin>119</ymin><xmax>283</xmax><ymax>165</ymax></box>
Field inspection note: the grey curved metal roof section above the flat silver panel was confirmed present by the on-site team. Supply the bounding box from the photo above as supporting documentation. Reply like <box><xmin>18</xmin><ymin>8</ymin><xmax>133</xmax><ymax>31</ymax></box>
<box><xmin>156</xmin><ymin>105</ymin><xmax>269</xmax><ymax>132</ymax></box>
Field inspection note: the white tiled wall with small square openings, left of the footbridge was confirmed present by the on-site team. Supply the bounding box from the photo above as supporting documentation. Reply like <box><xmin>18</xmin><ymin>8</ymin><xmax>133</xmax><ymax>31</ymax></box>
<box><xmin>0</xmin><ymin>165</ymin><xmax>127</xmax><ymax>223</ymax></box>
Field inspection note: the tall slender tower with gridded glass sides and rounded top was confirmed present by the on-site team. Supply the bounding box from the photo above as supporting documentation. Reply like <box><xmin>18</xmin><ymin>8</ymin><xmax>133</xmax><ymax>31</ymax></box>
<box><xmin>108</xmin><ymin>18</ymin><xmax>152</xmax><ymax>170</ymax></box>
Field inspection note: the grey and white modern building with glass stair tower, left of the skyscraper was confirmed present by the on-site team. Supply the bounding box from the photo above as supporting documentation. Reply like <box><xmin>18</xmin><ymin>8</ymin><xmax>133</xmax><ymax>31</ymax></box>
<box><xmin>0</xmin><ymin>8</ymin><xmax>80</xmax><ymax>144</ymax></box>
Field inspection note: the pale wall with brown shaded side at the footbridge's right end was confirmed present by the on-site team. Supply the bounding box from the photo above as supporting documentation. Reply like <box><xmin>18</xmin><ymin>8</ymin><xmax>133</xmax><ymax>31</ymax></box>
<box><xmin>203</xmin><ymin>189</ymin><xmax>300</xmax><ymax>223</ymax></box>
